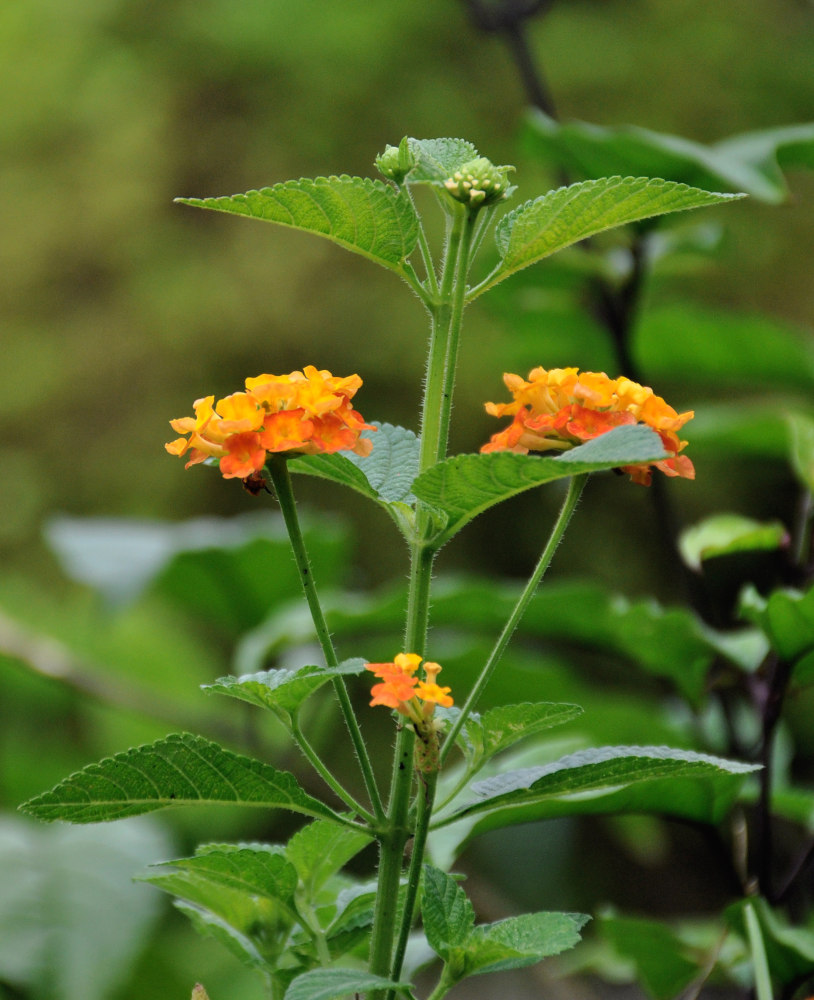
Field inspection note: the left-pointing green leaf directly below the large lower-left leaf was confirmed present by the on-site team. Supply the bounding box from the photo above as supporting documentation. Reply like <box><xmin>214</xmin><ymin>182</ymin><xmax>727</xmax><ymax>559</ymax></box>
<box><xmin>142</xmin><ymin>844</ymin><xmax>300</xmax><ymax>903</ymax></box>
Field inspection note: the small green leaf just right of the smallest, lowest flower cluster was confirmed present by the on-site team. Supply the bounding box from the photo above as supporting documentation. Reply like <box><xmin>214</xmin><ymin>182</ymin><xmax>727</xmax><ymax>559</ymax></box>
<box><xmin>446</xmin><ymin>701</ymin><xmax>582</xmax><ymax>762</ymax></box>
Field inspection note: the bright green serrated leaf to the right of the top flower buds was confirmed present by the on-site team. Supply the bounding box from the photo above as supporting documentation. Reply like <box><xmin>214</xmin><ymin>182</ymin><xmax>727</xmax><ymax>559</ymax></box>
<box><xmin>473</xmin><ymin>177</ymin><xmax>743</xmax><ymax>297</ymax></box>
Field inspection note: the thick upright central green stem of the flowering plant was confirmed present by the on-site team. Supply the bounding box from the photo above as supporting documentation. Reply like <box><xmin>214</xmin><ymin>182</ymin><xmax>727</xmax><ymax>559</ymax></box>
<box><xmin>370</xmin><ymin>197</ymin><xmax>476</xmax><ymax>1000</ymax></box>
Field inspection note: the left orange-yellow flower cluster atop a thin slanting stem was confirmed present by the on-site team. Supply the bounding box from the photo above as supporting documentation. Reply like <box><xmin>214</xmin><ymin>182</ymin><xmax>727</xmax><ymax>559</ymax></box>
<box><xmin>164</xmin><ymin>365</ymin><xmax>375</xmax><ymax>479</ymax></box>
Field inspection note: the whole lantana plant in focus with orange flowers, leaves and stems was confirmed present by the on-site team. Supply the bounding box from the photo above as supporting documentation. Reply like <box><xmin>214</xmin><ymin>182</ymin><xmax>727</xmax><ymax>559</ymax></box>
<box><xmin>19</xmin><ymin>138</ymin><xmax>754</xmax><ymax>1000</ymax></box>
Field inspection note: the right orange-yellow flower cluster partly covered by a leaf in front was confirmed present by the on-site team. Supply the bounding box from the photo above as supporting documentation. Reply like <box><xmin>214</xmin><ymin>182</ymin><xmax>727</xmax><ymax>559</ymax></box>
<box><xmin>481</xmin><ymin>368</ymin><xmax>695</xmax><ymax>486</ymax></box>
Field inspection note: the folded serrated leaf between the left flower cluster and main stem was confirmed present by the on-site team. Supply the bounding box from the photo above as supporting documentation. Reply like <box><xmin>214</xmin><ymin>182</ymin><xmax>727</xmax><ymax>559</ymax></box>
<box><xmin>289</xmin><ymin>422</ymin><xmax>419</xmax><ymax>504</ymax></box>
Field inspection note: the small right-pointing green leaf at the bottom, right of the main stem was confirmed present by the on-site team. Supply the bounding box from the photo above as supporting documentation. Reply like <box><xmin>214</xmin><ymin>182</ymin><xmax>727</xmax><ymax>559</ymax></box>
<box><xmin>465</xmin><ymin>913</ymin><xmax>590</xmax><ymax>976</ymax></box>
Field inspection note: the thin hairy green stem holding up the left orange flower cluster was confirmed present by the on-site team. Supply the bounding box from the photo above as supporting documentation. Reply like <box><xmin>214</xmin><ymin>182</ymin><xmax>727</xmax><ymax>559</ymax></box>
<box><xmin>268</xmin><ymin>455</ymin><xmax>384</xmax><ymax>820</ymax></box>
